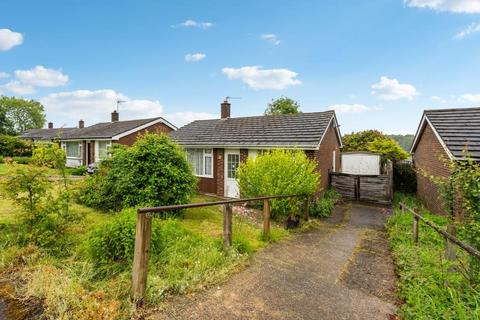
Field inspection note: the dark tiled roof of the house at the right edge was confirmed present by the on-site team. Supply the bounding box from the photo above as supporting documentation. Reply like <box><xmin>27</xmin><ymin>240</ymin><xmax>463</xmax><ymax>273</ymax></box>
<box><xmin>425</xmin><ymin>108</ymin><xmax>480</xmax><ymax>161</ymax></box>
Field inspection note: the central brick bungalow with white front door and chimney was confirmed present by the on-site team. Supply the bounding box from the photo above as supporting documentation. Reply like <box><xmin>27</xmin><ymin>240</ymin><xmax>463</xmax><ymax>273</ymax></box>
<box><xmin>170</xmin><ymin>101</ymin><xmax>342</xmax><ymax>198</ymax></box>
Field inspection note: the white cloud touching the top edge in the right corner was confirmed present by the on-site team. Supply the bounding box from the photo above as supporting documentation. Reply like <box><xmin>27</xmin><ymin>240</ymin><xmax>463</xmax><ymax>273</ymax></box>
<box><xmin>404</xmin><ymin>0</ymin><xmax>480</xmax><ymax>13</ymax></box>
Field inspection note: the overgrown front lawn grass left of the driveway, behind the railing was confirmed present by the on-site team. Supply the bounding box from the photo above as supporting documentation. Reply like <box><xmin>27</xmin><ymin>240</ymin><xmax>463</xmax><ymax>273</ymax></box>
<box><xmin>0</xmin><ymin>191</ymin><xmax>288</xmax><ymax>319</ymax></box>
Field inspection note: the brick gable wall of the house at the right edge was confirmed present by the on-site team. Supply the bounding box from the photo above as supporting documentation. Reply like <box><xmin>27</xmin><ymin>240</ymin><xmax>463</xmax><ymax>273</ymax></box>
<box><xmin>414</xmin><ymin>123</ymin><xmax>450</xmax><ymax>214</ymax></box>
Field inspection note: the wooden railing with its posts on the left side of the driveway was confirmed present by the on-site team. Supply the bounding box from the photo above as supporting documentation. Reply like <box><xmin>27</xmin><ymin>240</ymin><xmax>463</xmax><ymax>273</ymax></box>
<box><xmin>132</xmin><ymin>195</ymin><xmax>309</xmax><ymax>303</ymax></box>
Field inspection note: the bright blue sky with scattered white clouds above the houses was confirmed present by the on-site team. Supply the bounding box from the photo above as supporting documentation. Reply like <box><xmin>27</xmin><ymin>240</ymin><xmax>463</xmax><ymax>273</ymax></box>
<box><xmin>0</xmin><ymin>0</ymin><xmax>480</xmax><ymax>134</ymax></box>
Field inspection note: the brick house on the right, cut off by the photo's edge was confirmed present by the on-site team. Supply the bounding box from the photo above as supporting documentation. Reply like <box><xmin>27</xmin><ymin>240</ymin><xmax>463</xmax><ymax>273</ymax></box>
<box><xmin>410</xmin><ymin>108</ymin><xmax>480</xmax><ymax>214</ymax></box>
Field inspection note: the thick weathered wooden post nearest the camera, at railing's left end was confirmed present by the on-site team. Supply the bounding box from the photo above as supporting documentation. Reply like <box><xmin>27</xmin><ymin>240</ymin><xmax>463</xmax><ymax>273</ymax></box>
<box><xmin>132</xmin><ymin>212</ymin><xmax>152</xmax><ymax>304</ymax></box>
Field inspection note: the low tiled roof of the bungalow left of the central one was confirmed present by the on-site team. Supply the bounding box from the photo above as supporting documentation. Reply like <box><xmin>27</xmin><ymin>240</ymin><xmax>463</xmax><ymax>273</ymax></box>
<box><xmin>62</xmin><ymin>117</ymin><xmax>166</xmax><ymax>140</ymax></box>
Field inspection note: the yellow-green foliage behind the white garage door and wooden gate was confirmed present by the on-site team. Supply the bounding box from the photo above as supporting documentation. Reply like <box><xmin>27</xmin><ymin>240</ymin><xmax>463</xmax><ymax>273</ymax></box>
<box><xmin>342</xmin><ymin>130</ymin><xmax>408</xmax><ymax>161</ymax></box>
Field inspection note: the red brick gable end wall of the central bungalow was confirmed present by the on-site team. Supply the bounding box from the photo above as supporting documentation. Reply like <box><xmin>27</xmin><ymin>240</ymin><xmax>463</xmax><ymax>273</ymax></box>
<box><xmin>316</xmin><ymin>123</ymin><xmax>340</xmax><ymax>192</ymax></box>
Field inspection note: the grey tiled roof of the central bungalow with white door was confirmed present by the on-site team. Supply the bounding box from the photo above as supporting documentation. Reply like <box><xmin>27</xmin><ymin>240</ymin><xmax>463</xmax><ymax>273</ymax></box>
<box><xmin>170</xmin><ymin>111</ymin><xmax>335</xmax><ymax>149</ymax></box>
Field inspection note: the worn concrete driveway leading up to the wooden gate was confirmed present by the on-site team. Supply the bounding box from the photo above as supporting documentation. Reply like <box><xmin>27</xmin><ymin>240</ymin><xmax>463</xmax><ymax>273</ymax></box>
<box><xmin>151</xmin><ymin>205</ymin><xmax>395</xmax><ymax>320</ymax></box>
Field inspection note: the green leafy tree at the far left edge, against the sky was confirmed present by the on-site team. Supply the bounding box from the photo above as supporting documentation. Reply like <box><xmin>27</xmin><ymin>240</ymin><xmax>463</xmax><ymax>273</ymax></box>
<box><xmin>0</xmin><ymin>97</ymin><xmax>46</xmax><ymax>135</ymax></box>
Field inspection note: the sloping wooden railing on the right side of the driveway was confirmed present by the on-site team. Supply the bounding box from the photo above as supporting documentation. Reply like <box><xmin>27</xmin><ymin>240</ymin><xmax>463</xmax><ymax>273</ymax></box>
<box><xmin>400</xmin><ymin>203</ymin><xmax>480</xmax><ymax>259</ymax></box>
